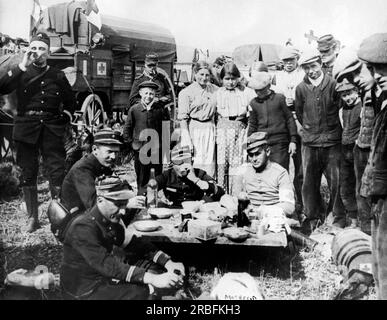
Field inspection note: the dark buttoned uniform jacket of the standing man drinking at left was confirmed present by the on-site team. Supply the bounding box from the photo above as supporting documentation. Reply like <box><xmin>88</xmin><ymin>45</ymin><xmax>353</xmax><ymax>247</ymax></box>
<box><xmin>0</xmin><ymin>65</ymin><xmax>75</xmax><ymax>144</ymax></box>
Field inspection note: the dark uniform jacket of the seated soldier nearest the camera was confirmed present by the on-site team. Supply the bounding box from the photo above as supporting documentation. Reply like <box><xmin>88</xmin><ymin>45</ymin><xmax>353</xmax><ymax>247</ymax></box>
<box><xmin>60</xmin><ymin>206</ymin><xmax>170</xmax><ymax>298</ymax></box>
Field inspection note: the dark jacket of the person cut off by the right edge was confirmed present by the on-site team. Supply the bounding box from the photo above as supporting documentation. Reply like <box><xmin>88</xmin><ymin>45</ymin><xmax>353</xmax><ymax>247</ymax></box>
<box><xmin>360</xmin><ymin>93</ymin><xmax>387</xmax><ymax>201</ymax></box>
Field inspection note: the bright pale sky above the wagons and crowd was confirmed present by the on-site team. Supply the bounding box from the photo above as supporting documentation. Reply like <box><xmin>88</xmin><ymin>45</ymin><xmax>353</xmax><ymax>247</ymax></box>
<box><xmin>0</xmin><ymin>0</ymin><xmax>387</xmax><ymax>52</ymax></box>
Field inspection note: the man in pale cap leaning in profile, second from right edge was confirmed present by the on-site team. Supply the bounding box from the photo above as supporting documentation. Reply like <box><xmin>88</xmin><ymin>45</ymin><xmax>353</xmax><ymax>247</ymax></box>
<box><xmin>333</xmin><ymin>47</ymin><xmax>381</xmax><ymax>234</ymax></box>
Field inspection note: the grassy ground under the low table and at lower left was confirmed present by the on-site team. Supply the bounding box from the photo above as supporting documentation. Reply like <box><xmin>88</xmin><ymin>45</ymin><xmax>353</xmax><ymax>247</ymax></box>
<box><xmin>0</xmin><ymin>162</ymin><xmax>375</xmax><ymax>300</ymax></box>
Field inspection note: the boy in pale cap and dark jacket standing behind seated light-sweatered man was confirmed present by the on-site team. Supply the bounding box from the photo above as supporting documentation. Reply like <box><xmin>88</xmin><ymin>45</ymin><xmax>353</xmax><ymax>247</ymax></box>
<box><xmin>247</xmin><ymin>72</ymin><xmax>297</xmax><ymax>170</ymax></box>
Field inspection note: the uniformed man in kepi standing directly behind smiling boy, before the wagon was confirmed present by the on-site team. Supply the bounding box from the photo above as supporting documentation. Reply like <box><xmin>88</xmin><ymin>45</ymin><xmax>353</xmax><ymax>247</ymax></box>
<box><xmin>129</xmin><ymin>53</ymin><xmax>172</xmax><ymax>106</ymax></box>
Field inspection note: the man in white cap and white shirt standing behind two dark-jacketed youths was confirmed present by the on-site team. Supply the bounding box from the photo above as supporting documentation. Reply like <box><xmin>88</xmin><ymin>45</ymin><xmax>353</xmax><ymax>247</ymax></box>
<box><xmin>273</xmin><ymin>46</ymin><xmax>305</xmax><ymax>218</ymax></box>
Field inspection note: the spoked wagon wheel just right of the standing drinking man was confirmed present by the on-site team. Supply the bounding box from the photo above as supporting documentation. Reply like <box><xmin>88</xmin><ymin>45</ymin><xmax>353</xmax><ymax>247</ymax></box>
<box><xmin>81</xmin><ymin>94</ymin><xmax>106</xmax><ymax>132</ymax></box>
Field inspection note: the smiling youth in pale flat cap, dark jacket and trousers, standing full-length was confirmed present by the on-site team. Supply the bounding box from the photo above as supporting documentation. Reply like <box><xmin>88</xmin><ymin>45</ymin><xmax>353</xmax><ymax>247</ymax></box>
<box><xmin>295</xmin><ymin>49</ymin><xmax>345</xmax><ymax>234</ymax></box>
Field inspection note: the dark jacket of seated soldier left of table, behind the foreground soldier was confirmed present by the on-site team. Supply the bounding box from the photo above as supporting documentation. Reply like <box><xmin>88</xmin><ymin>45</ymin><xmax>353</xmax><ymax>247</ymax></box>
<box><xmin>61</xmin><ymin>154</ymin><xmax>112</xmax><ymax>211</ymax></box>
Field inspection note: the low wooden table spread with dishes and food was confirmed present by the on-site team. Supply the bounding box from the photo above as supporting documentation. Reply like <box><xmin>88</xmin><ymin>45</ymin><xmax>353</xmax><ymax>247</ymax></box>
<box><xmin>128</xmin><ymin>209</ymin><xmax>288</xmax><ymax>248</ymax></box>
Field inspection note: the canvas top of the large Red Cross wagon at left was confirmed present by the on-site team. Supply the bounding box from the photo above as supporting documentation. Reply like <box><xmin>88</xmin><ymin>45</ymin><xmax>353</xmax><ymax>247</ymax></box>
<box><xmin>32</xmin><ymin>1</ymin><xmax>176</xmax><ymax>63</ymax></box>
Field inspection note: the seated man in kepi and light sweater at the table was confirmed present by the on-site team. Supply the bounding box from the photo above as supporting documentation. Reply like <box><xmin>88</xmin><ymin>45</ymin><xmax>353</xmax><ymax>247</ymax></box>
<box><xmin>233</xmin><ymin>132</ymin><xmax>295</xmax><ymax>217</ymax></box>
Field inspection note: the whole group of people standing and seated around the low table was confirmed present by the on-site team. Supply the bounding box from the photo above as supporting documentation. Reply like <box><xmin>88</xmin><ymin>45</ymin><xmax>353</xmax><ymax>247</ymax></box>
<box><xmin>0</xmin><ymin>29</ymin><xmax>387</xmax><ymax>299</ymax></box>
